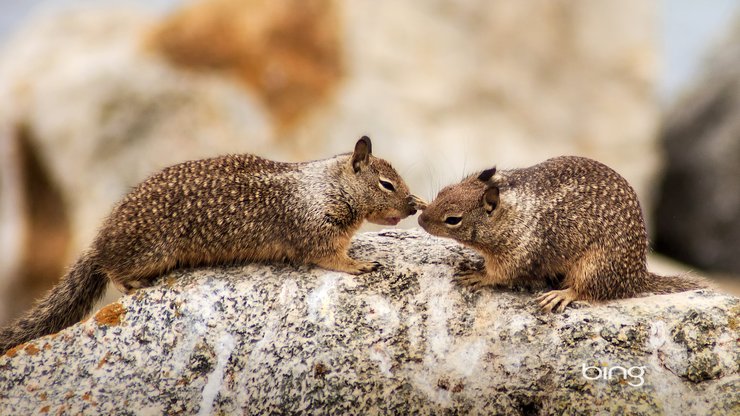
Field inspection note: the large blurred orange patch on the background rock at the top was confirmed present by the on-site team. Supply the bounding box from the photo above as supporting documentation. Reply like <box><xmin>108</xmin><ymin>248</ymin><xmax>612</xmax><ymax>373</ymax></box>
<box><xmin>146</xmin><ymin>0</ymin><xmax>342</xmax><ymax>127</ymax></box>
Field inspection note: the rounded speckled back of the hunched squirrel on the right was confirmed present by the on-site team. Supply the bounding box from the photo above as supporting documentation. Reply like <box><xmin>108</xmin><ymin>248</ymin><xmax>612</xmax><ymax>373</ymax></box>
<box><xmin>501</xmin><ymin>156</ymin><xmax>648</xmax><ymax>272</ymax></box>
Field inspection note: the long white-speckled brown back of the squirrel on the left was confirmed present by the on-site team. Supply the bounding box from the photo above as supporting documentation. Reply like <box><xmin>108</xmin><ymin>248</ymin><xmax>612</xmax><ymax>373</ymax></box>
<box><xmin>94</xmin><ymin>155</ymin><xmax>302</xmax><ymax>277</ymax></box>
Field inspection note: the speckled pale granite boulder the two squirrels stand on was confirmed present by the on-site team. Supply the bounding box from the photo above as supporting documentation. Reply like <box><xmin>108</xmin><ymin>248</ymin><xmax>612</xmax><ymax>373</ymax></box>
<box><xmin>0</xmin><ymin>231</ymin><xmax>740</xmax><ymax>415</ymax></box>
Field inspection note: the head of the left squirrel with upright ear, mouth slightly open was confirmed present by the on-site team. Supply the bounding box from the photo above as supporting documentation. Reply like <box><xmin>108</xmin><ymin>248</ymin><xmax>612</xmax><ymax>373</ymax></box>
<box><xmin>347</xmin><ymin>136</ymin><xmax>423</xmax><ymax>225</ymax></box>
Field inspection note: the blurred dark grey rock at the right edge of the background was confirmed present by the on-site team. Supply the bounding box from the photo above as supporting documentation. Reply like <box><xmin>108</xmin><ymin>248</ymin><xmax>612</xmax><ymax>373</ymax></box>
<box><xmin>655</xmin><ymin>18</ymin><xmax>740</xmax><ymax>276</ymax></box>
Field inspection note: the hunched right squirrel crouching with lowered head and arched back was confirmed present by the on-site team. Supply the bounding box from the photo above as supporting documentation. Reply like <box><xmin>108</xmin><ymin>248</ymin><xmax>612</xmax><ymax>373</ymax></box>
<box><xmin>418</xmin><ymin>156</ymin><xmax>706</xmax><ymax>312</ymax></box>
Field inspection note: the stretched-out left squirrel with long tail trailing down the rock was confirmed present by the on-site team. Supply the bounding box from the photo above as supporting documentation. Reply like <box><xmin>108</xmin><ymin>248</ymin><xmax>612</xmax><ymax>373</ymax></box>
<box><xmin>0</xmin><ymin>136</ymin><xmax>424</xmax><ymax>354</ymax></box>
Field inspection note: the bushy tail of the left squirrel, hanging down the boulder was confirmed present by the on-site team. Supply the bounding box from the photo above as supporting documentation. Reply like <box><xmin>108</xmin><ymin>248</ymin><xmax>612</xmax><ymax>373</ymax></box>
<box><xmin>0</xmin><ymin>253</ymin><xmax>108</xmax><ymax>355</ymax></box>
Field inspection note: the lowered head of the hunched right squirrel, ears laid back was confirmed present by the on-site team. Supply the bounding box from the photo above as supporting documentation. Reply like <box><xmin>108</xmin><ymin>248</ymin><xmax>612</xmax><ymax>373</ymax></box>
<box><xmin>419</xmin><ymin>167</ymin><xmax>511</xmax><ymax>247</ymax></box>
